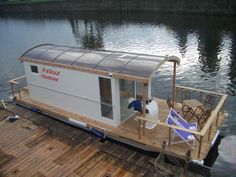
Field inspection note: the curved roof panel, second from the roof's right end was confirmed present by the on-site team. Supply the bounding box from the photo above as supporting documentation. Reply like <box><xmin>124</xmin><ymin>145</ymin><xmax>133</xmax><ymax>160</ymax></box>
<box><xmin>96</xmin><ymin>53</ymin><xmax>136</xmax><ymax>73</ymax></box>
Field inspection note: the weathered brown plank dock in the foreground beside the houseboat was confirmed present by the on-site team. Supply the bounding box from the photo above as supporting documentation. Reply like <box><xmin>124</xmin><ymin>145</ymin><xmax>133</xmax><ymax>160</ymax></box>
<box><xmin>0</xmin><ymin>104</ymin><xmax>204</xmax><ymax>177</ymax></box>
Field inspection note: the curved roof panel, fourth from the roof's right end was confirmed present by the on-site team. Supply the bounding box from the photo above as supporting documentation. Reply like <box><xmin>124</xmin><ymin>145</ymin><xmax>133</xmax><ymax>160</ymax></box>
<box><xmin>53</xmin><ymin>49</ymin><xmax>86</xmax><ymax>65</ymax></box>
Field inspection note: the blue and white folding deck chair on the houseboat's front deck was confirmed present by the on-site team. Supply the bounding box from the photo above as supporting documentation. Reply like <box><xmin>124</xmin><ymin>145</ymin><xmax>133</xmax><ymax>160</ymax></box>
<box><xmin>166</xmin><ymin>108</ymin><xmax>197</xmax><ymax>148</ymax></box>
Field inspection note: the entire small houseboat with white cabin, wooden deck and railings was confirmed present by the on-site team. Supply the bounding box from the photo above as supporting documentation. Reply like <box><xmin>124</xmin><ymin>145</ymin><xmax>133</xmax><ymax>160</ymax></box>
<box><xmin>10</xmin><ymin>44</ymin><xmax>227</xmax><ymax>162</ymax></box>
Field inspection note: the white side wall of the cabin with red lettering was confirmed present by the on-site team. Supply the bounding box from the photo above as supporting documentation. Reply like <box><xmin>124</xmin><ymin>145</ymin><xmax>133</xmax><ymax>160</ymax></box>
<box><xmin>24</xmin><ymin>62</ymin><xmax>117</xmax><ymax>126</ymax></box>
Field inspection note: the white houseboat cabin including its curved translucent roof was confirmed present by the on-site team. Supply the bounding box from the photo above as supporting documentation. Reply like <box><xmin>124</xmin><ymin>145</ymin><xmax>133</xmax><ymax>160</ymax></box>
<box><xmin>20</xmin><ymin>44</ymin><xmax>179</xmax><ymax>127</ymax></box>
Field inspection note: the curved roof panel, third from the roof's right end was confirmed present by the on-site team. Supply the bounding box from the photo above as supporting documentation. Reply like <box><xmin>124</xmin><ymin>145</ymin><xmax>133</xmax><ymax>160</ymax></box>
<box><xmin>73</xmin><ymin>51</ymin><xmax>111</xmax><ymax>68</ymax></box>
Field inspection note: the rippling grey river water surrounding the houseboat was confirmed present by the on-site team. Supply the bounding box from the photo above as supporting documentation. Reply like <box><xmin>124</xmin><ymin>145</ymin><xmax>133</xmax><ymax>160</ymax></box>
<box><xmin>0</xmin><ymin>13</ymin><xmax>236</xmax><ymax>176</ymax></box>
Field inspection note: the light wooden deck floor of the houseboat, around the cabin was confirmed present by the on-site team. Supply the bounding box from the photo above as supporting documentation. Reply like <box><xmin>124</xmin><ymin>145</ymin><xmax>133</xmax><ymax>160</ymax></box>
<box><xmin>12</xmin><ymin>89</ymin><xmax>224</xmax><ymax>161</ymax></box>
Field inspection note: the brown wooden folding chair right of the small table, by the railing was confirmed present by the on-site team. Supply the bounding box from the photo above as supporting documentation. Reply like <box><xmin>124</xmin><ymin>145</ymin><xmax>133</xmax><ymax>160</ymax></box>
<box><xmin>196</xmin><ymin>95</ymin><xmax>215</xmax><ymax>128</ymax></box>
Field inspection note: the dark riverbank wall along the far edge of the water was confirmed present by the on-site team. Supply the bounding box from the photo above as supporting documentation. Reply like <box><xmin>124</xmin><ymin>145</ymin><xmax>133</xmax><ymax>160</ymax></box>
<box><xmin>0</xmin><ymin>0</ymin><xmax>236</xmax><ymax>15</ymax></box>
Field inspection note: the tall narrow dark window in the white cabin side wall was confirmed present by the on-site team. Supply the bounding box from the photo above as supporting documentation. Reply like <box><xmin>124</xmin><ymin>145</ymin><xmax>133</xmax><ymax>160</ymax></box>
<box><xmin>99</xmin><ymin>77</ymin><xmax>113</xmax><ymax>119</ymax></box>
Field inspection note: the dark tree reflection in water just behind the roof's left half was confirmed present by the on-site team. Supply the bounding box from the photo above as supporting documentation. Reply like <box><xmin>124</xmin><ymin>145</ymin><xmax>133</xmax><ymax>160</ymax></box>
<box><xmin>69</xmin><ymin>19</ymin><xmax>104</xmax><ymax>49</ymax></box>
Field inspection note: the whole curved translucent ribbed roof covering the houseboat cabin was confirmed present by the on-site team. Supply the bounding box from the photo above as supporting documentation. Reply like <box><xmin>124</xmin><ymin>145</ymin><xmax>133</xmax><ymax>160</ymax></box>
<box><xmin>20</xmin><ymin>44</ymin><xmax>179</xmax><ymax>79</ymax></box>
